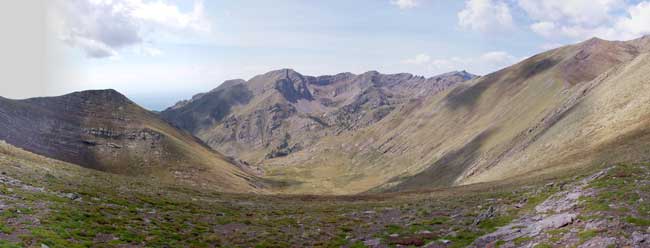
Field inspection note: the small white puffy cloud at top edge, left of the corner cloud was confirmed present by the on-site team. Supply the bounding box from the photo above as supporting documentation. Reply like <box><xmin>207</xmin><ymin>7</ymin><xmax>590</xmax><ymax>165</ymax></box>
<box><xmin>458</xmin><ymin>0</ymin><xmax>514</xmax><ymax>32</ymax></box>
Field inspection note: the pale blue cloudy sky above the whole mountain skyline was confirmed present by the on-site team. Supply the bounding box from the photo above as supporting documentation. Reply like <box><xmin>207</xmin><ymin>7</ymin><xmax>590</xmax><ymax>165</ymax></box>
<box><xmin>0</xmin><ymin>0</ymin><xmax>650</xmax><ymax>110</ymax></box>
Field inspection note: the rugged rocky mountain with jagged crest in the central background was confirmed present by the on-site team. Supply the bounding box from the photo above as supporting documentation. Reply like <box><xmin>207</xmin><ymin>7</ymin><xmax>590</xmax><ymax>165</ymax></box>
<box><xmin>161</xmin><ymin>69</ymin><xmax>475</xmax><ymax>163</ymax></box>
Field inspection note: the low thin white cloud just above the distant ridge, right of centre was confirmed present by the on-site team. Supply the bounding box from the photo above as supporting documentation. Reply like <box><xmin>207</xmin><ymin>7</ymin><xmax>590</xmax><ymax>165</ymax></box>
<box><xmin>402</xmin><ymin>51</ymin><xmax>521</xmax><ymax>75</ymax></box>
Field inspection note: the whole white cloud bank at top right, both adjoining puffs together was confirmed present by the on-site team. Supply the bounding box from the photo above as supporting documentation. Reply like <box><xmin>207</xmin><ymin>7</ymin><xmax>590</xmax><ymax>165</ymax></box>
<box><xmin>458</xmin><ymin>0</ymin><xmax>650</xmax><ymax>43</ymax></box>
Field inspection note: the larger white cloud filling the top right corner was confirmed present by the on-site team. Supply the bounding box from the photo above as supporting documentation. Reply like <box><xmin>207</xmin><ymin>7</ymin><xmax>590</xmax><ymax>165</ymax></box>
<box><xmin>518</xmin><ymin>0</ymin><xmax>650</xmax><ymax>41</ymax></box>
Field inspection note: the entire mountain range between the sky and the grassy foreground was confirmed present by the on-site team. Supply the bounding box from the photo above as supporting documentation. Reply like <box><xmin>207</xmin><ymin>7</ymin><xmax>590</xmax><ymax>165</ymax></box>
<box><xmin>5</xmin><ymin>36</ymin><xmax>650</xmax><ymax>197</ymax></box>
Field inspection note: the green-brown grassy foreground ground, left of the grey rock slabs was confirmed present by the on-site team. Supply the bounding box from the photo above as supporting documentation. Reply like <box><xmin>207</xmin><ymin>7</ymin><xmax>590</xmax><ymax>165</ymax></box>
<box><xmin>0</xmin><ymin>140</ymin><xmax>604</xmax><ymax>247</ymax></box>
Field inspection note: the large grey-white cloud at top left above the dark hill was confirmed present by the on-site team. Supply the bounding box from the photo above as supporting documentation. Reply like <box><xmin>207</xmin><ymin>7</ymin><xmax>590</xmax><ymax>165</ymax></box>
<box><xmin>48</xmin><ymin>0</ymin><xmax>209</xmax><ymax>58</ymax></box>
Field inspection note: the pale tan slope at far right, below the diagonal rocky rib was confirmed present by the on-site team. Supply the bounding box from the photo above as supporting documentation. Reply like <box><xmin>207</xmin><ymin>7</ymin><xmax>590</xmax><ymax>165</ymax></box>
<box><xmin>466</xmin><ymin>54</ymin><xmax>650</xmax><ymax>183</ymax></box>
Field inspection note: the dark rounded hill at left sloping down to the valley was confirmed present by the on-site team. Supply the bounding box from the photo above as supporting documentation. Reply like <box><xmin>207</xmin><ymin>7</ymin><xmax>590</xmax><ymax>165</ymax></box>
<box><xmin>0</xmin><ymin>90</ymin><xmax>255</xmax><ymax>192</ymax></box>
